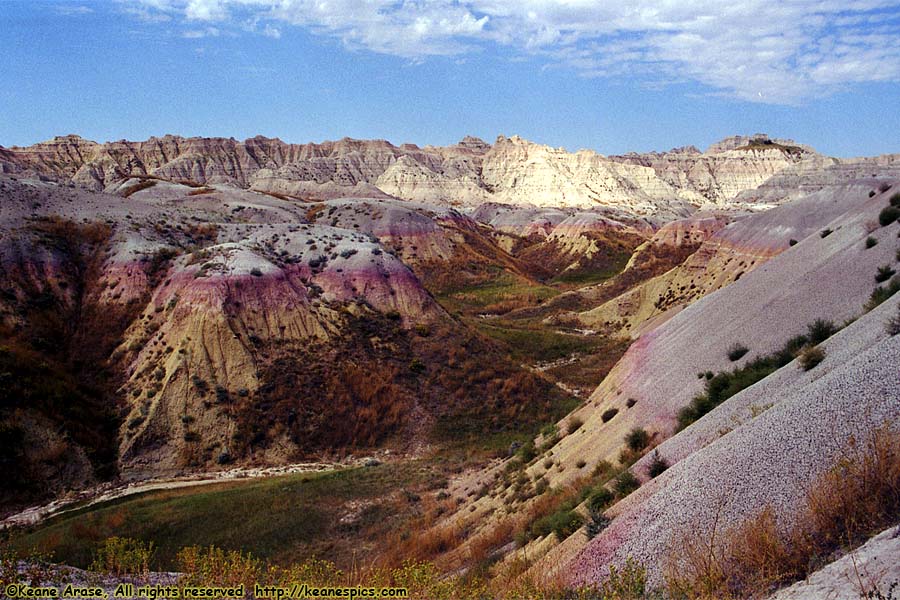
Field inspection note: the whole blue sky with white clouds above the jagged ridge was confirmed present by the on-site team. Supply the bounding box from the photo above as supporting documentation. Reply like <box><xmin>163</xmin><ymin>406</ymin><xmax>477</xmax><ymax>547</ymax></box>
<box><xmin>0</xmin><ymin>0</ymin><xmax>900</xmax><ymax>156</ymax></box>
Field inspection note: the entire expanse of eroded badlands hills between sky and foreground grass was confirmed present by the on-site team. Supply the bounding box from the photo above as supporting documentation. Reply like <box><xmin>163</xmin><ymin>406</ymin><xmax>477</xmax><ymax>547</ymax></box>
<box><xmin>0</xmin><ymin>135</ymin><xmax>900</xmax><ymax>598</ymax></box>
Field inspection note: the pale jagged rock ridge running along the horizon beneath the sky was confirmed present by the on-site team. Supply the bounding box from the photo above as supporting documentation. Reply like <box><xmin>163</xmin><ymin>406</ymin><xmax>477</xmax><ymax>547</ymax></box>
<box><xmin>7</xmin><ymin>134</ymin><xmax>900</xmax><ymax>219</ymax></box>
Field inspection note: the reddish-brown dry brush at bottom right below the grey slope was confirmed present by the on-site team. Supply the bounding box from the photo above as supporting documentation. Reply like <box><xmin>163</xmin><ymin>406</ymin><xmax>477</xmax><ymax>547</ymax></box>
<box><xmin>666</xmin><ymin>426</ymin><xmax>900</xmax><ymax>599</ymax></box>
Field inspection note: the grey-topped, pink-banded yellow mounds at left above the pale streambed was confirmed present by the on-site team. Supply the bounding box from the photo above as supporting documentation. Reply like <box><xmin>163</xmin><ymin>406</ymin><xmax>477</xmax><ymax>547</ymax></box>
<box><xmin>0</xmin><ymin>179</ymin><xmax>454</xmax><ymax>486</ymax></box>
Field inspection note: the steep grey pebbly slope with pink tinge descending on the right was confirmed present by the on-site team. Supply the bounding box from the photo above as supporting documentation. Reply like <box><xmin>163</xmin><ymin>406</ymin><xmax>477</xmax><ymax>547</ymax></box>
<box><xmin>516</xmin><ymin>186</ymin><xmax>900</xmax><ymax>585</ymax></box>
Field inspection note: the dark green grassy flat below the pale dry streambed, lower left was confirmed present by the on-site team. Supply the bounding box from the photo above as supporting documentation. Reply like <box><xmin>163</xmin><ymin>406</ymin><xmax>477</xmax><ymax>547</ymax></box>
<box><xmin>12</xmin><ymin>462</ymin><xmax>437</xmax><ymax>569</ymax></box>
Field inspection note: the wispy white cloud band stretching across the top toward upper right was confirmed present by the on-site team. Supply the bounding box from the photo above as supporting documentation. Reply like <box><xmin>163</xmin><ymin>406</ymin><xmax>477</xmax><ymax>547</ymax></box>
<box><xmin>126</xmin><ymin>0</ymin><xmax>900</xmax><ymax>104</ymax></box>
